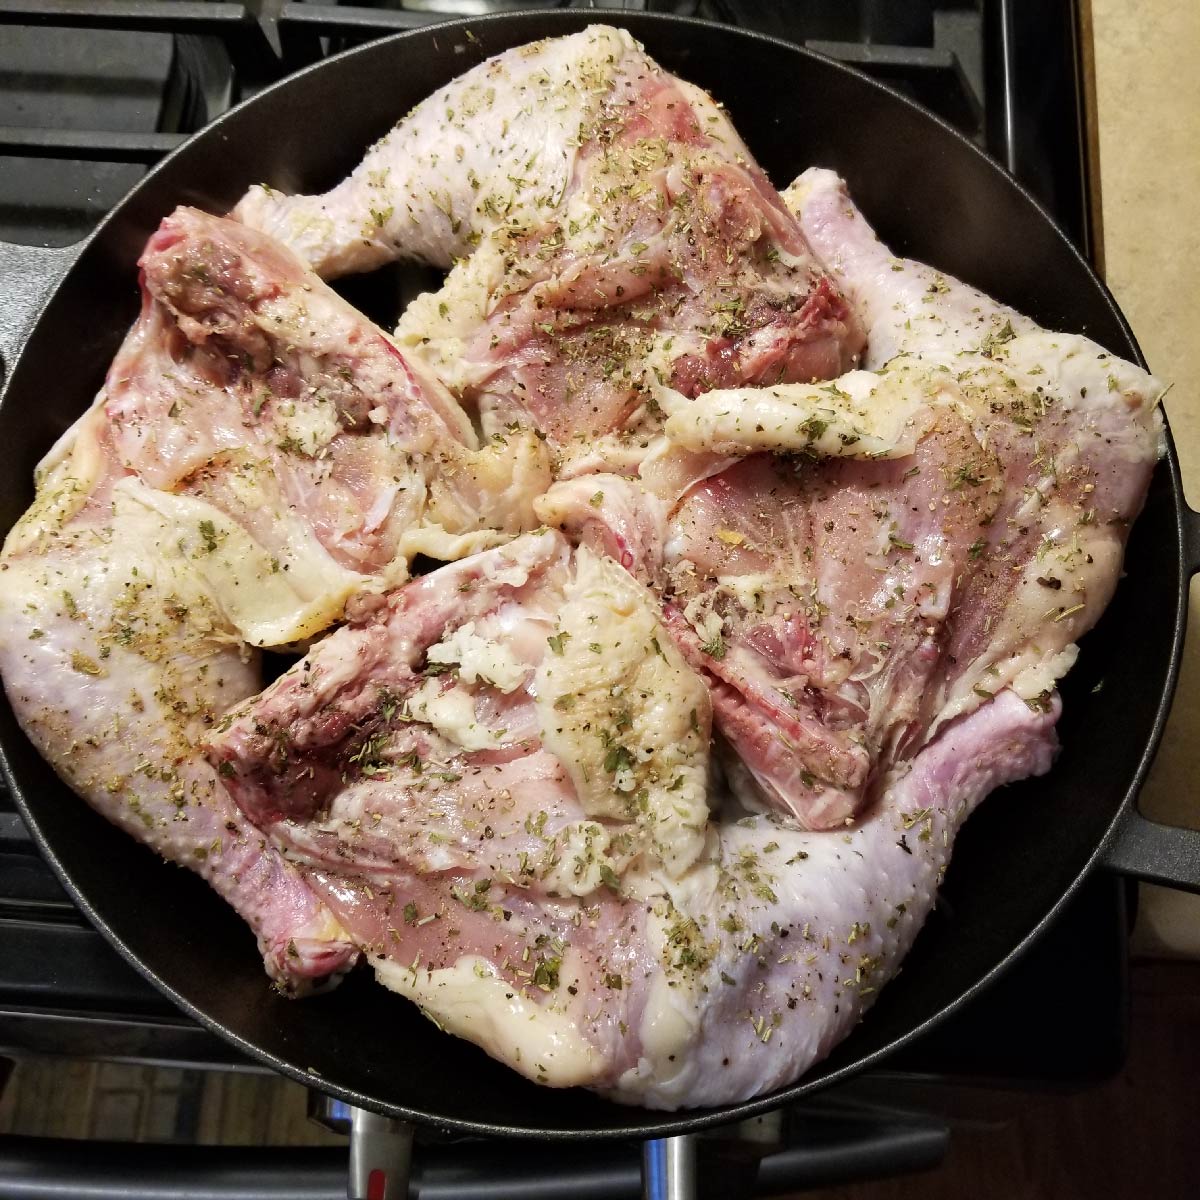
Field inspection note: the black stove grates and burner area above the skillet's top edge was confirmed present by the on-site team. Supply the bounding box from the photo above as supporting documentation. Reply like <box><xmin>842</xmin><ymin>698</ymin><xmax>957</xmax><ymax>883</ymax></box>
<box><xmin>0</xmin><ymin>0</ymin><xmax>1092</xmax><ymax>252</ymax></box>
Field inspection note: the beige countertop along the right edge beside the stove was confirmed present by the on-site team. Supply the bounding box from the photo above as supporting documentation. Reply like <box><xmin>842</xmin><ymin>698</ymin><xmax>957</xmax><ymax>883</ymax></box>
<box><xmin>1081</xmin><ymin>0</ymin><xmax>1200</xmax><ymax>958</ymax></box>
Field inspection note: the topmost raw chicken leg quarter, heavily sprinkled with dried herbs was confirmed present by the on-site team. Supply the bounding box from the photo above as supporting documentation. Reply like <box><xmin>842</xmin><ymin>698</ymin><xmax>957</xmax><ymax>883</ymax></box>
<box><xmin>236</xmin><ymin>26</ymin><xmax>863</xmax><ymax>460</ymax></box>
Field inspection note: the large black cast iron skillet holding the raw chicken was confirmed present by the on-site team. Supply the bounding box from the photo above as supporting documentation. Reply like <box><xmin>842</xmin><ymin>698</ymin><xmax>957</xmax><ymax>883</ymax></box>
<box><xmin>0</xmin><ymin>12</ymin><xmax>1200</xmax><ymax>1138</ymax></box>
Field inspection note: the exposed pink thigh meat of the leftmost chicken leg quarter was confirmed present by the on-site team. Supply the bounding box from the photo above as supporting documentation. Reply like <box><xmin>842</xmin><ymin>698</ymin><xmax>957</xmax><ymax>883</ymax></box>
<box><xmin>130</xmin><ymin>209</ymin><xmax>550</xmax><ymax>600</ymax></box>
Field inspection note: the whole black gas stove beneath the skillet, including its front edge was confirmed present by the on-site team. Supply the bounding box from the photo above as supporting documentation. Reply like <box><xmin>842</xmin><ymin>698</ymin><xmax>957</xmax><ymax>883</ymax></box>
<box><xmin>0</xmin><ymin>0</ymin><xmax>1130</xmax><ymax>1200</ymax></box>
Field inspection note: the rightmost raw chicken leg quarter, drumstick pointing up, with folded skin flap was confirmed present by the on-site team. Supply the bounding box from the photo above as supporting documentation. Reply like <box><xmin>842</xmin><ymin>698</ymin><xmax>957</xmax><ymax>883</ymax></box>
<box><xmin>638</xmin><ymin>172</ymin><xmax>1162</xmax><ymax>829</ymax></box>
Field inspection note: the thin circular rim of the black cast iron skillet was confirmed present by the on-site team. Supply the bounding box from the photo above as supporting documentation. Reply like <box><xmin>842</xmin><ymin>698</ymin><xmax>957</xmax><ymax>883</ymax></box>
<box><xmin>0</xmin><ymin>10</ymin><xmax>1188</xmax><ymax>1140</ymax></box>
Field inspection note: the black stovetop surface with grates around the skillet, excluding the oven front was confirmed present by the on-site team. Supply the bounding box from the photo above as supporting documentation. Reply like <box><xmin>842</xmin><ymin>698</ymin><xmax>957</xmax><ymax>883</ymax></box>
<box><xmin>0</xmin><ymin>0</ymin><xmax>1113</xmax><ymax>1087</ymax></box>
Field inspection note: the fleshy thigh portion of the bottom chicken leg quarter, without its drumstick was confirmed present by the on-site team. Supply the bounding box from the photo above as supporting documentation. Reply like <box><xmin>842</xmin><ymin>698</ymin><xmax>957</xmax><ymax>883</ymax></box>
<box><xmin>209</xmin><ymin>532</ymin><xmax>709</xmax><ymax>1087</ymax></box>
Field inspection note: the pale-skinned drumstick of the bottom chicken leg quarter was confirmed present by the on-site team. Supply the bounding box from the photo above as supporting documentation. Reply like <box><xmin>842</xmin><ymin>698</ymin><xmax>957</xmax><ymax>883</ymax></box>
<box><xmin>614</xmin><ymin>691</ymin><xmax>1058</xmax><ymax>1109</ymax></box>
